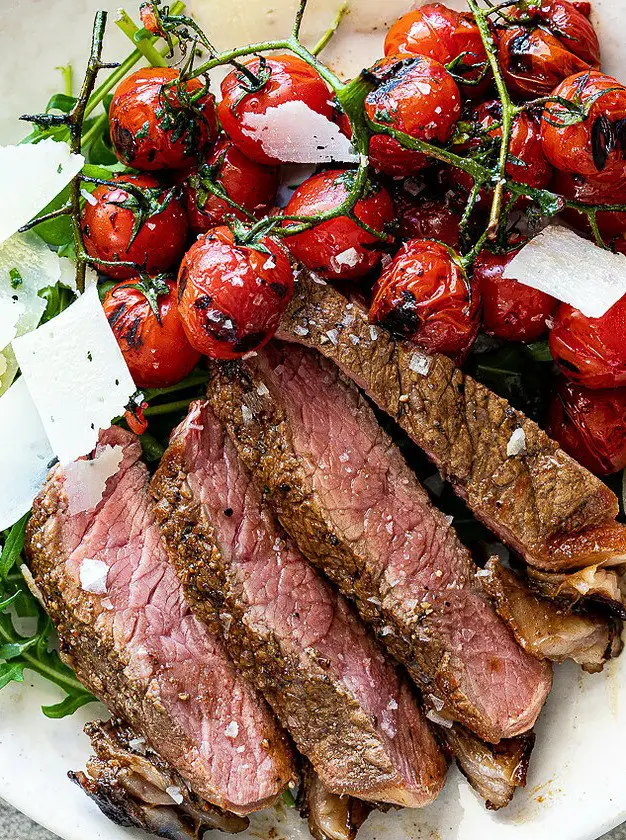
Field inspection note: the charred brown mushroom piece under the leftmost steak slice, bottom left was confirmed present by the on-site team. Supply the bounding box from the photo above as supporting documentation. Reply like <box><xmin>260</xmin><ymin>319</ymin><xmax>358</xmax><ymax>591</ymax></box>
<box><xmin>68</xmin><ymin>720</ymin><xmax>248</xmax><ymax>840</ymax></box>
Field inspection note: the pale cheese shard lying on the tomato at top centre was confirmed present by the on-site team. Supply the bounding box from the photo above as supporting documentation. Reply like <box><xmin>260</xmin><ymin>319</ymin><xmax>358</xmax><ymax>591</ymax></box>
<box><xmin>241</xmin><ymin>100</ymin><xmax>359</xmax><ymax>163</ymax></box>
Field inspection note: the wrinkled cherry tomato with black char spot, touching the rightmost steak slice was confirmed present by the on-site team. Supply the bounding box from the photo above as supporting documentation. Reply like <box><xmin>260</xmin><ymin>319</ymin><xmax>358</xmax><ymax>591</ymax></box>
<box><xmin>369</xmin><ymin>239</ymin><xmax>480</xmax><ymax>363</ymax></box>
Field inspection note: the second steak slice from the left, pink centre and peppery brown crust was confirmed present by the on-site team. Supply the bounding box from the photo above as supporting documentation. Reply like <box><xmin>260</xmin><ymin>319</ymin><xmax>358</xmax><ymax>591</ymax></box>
<box><xmin>152</xmin><ymin>402</ymin><xmax>446</xmax><ymax>808</ymax></box>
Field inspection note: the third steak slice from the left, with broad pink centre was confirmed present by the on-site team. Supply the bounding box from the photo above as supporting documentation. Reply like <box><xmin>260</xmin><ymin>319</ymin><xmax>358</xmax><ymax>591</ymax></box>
<box><xmin>209</xmin><ymin>352</ymin><xmax>551</xmax><ymax>742</ymax></box>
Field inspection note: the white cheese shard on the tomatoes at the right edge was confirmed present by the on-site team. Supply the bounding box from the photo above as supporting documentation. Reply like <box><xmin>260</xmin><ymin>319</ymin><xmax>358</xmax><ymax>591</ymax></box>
<box><xmin>503</xmin><ymin>225</ymin><xmax>626</xmax><ymax>318</ymax></box>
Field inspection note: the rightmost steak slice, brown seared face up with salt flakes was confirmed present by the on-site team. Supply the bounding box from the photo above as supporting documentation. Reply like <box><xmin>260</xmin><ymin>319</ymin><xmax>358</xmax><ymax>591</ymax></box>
<box><xmin>278</xmin><ymin>271</ymin><xmax>626</xmax><ymax>570</ymax></box>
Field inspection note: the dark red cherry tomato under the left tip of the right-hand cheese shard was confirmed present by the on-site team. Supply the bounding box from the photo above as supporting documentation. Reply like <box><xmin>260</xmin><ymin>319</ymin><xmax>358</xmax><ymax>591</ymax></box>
<box><xmin>474</xmin><ymin>251</ymin><xmax>558</xmax><ymax>342</ymax></box>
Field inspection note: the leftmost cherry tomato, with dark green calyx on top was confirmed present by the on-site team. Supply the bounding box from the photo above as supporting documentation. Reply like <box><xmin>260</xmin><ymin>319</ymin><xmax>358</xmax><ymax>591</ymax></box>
<box><xmin>81</xmin><ymin>174</ymin><xmax>188</xmax><ymax>280</ymax></box>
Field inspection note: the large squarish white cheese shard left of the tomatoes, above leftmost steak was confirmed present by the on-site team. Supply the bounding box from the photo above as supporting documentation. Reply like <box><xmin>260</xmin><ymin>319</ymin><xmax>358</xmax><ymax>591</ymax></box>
<box><xmin>13</xmin><ymin>286</ymin><xmax>136</xmax><ymax>464</ymax></box>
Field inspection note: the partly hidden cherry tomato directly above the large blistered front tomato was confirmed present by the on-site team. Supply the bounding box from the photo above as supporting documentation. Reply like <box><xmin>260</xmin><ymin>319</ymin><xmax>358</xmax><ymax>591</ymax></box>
<box><xmin>185</xmin><ymin>138</ymin><xmax>278</xmax><ymax>233</ymax></box>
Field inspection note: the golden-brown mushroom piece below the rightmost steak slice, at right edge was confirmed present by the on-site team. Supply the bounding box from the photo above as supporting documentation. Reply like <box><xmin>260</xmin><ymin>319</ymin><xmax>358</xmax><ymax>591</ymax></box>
<box><xmin>480</xmin><ymin>558</ymin><xmax>622</xmax><ymax>673</ymax></box>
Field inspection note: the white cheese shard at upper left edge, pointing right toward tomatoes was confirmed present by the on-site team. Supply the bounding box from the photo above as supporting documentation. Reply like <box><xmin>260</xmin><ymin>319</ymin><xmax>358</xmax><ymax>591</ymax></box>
<box><xmin>0</xmin><ymin>140</ymin><xmax>85</xmax><ymax>242</ymax></box>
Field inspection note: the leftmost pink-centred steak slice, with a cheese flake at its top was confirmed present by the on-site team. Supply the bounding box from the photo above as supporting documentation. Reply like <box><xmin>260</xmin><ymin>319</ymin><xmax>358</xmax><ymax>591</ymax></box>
<box><xmin>26</xmin><ymin>428</ymin><xmax>294</xmax><ymax>814</ymax></box>
